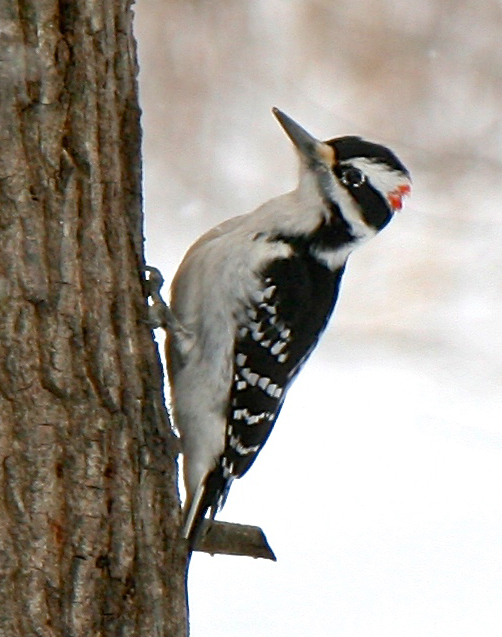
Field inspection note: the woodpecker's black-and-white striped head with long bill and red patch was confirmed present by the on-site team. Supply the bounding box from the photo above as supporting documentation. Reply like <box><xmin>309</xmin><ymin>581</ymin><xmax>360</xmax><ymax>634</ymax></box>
<box><xmin>273</xmin><ymin>108</ymin><xmax>411</xmax><ymax>238</ymax></box>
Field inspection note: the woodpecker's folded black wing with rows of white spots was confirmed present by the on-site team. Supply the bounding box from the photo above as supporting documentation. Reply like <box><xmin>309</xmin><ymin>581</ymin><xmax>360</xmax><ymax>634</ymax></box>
<box><xmin>213</xmin><ymin>255</ymin><xmax>343</xmax><ymax>511</ymax></box>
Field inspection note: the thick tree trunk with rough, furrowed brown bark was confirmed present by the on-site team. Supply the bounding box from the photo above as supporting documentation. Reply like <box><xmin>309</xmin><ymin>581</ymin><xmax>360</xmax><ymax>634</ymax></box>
<box><xmin>0</xmin><ymin>0</ymin><xmax>186</xmax><ymax>637</ymax></box>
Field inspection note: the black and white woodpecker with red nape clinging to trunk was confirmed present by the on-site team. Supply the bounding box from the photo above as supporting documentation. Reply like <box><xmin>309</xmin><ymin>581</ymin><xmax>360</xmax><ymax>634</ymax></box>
<box><xmin>147</xmin><ymin>108</ymin><xmax>411</xmax><ymax>546</ymax></box>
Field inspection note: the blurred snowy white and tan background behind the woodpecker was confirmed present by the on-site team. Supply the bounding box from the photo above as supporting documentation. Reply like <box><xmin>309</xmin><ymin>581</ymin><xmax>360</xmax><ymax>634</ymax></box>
<box><xmin>135</xmin><ymin>0</ymin><xmax>502</xmax><ymax>637</ymax></box>
